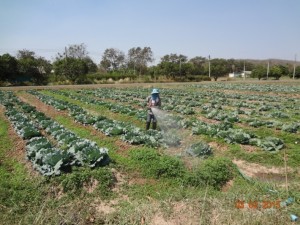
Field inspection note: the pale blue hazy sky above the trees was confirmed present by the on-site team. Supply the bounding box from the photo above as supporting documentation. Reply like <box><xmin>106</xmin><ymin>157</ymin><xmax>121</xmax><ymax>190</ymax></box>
<box><xmin>0</xmin><ymin>0</ymin><xmax>300</xmax><ymax>63</ymax></box>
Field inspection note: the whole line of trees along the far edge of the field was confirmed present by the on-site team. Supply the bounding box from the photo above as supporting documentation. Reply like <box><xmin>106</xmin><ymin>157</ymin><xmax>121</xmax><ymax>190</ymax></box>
<box><xmin>0</xmin><ymin>44</ymin><xmax>300</xmax><ymax>85</ymax></box>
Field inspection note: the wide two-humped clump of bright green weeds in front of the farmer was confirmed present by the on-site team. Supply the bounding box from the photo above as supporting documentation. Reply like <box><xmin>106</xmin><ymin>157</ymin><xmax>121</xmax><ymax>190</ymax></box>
<box><xmin>129</xmin><ymin>149</ymin><xmax>237</xmax><ymax>190</ymax></box>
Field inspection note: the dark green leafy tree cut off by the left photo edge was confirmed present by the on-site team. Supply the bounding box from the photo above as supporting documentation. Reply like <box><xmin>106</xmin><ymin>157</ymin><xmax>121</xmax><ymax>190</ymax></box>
<box><xmin>0</xmin><ymin>54</ymin><xmax>18</xmax><ymax>81</ymax></box>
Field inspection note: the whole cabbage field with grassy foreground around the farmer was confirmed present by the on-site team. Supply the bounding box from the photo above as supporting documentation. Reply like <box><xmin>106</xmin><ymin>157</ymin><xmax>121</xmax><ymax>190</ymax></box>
<box><xmin>0</xmin><ymin>82</ymin><xmax>300</xmax><ymax>224</ymax></box>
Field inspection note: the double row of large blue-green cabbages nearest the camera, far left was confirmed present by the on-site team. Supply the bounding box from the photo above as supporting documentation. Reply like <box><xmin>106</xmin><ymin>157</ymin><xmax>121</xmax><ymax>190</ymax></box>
<box><xmin>0</xmin><ymin>92</ymin><xmax>109</xmax><ymax>176</ymax></box>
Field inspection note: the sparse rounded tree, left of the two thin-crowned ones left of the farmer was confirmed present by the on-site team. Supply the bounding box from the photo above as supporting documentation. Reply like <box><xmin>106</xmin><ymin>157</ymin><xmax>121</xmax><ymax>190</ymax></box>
<box><xmin>100</xmin><ymin>48</ymin><xmax>125</xmax><ymax>71</ymax></box>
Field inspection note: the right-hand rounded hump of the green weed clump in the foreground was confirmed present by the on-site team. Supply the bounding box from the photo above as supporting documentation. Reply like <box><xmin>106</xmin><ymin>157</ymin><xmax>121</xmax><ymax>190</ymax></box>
<box><xmin>187</xmin><ymin>158</ymin><xmax>236</xmax><ymax>190</ymax></box>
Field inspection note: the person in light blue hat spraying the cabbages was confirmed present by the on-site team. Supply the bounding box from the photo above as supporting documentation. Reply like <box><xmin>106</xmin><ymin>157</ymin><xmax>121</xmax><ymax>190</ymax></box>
<box><xmin>146</xmin><ymin>88</ymin><xmax>161</xmax><ymax>130</ymax></box>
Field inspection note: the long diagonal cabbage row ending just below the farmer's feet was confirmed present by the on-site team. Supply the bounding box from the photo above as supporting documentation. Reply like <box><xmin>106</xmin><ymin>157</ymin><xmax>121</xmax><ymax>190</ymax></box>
<box><xmin>29</xmin><ymin>91</ymin><xmax>180</xmax><ymax>147</ymax></box>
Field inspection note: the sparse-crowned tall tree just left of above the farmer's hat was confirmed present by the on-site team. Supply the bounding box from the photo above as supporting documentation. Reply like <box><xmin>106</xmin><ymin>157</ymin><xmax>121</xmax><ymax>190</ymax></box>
<box><xmin>128</xmin><ymin>47</ymin><xmax>153</xmax><ymax>75</ymax></box>
